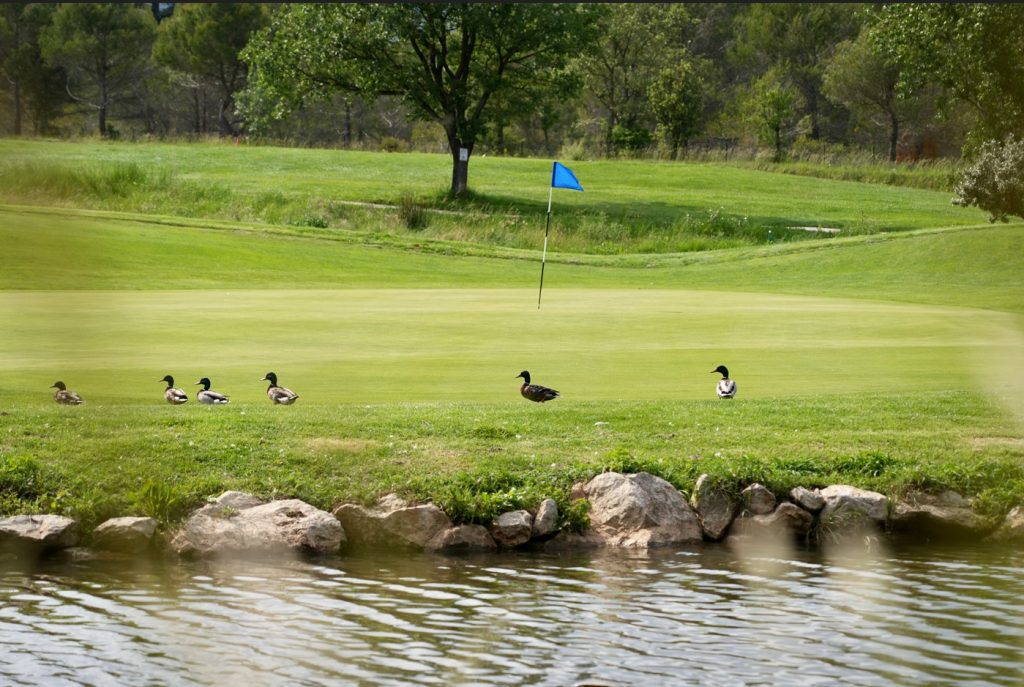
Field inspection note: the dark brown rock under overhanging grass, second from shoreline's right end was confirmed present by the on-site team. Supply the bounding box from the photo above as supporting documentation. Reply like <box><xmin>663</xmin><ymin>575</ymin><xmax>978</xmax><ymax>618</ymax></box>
<box><xmin>890</xmin><ymin>491</ymin><xmax>991</xmax><ymax>540</ymax></box>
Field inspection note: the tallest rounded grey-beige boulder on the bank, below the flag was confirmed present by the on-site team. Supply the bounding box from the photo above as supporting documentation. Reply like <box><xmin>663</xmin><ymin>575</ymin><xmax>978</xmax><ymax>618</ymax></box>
<box><xmin>584</xmin><ymin>472</ymin><xmax>701</xmax><ymax>548</ymax></box>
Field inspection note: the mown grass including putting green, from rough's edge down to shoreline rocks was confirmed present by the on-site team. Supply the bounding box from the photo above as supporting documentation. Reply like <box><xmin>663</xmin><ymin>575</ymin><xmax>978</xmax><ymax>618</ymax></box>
<box><xmin>0</xmin><ymin>139</ymin><xmax>1024</xmax><ymax>524</ymax></box>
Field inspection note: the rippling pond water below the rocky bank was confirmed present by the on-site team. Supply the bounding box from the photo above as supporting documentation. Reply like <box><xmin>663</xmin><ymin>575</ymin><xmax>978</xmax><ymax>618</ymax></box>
<box><xmin>0</xmin><ymin>547</ymin><xmax>1024</xmax><ymax>687</ymax></box>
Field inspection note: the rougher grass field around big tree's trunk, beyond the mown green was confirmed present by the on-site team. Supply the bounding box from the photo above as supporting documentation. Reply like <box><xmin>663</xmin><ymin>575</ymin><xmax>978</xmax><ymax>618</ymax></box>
<box><xmin>0</xmin><ymin>139</ymin><xmax>984</xmax><ymax>254</ymax></box>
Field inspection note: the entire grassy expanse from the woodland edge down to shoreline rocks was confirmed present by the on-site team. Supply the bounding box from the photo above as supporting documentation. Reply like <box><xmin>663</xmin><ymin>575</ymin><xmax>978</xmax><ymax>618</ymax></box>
<box><xmin>0</xmin><ymin>141</ymin><xmax>1024</xmax><ymax>527</ymax></box>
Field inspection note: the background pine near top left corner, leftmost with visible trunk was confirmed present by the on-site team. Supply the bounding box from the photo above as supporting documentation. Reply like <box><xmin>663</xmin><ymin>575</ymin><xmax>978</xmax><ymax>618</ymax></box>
<box><xmin>40</xmin><ymin>3</ymin><xmax>156</xmax><ymax>136</ymax></box>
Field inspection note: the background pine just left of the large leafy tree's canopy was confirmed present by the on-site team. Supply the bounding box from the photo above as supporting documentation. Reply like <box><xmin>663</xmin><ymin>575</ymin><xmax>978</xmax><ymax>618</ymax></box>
<box><xmin>153</xmin><ymin>3</ymin><xmax>268</xmax><ymax>136</ymax></box>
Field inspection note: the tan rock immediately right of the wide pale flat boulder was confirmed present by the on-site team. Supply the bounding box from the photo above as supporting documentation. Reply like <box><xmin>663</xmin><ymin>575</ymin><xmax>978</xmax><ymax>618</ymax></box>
<box><xmin>334</xmin><ymin>493</ymin><xmax>452</xmax><ymax>549</ymax></box>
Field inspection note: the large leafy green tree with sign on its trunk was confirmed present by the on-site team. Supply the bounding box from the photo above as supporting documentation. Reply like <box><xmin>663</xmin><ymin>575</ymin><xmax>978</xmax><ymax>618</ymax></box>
<box><xmin>243</xmin><ymin>3</ymin><xmax>597</xmax><ymax>196</ymax></box>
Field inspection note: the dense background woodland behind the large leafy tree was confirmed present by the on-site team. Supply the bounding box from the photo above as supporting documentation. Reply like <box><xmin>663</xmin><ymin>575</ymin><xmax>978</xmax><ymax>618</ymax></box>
<box><xmin>0</xmin><ymin>3</ymin><xmax>1024</xmax><ymax>161</ymax></box>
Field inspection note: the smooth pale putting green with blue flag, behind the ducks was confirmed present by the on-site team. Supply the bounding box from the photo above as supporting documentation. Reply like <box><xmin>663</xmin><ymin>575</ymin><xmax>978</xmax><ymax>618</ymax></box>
<box><xmin>0</xmin><ymin>289</ymin><xmax>1020</xmax><ymax>405</ymax></box>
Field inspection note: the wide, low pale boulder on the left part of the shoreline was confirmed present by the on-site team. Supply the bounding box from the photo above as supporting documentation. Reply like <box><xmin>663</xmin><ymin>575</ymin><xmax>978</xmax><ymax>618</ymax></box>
<box><xmin>171</xmin><ymin>499</ymin><xmax>345</xmax><ymax>557</ymax></box>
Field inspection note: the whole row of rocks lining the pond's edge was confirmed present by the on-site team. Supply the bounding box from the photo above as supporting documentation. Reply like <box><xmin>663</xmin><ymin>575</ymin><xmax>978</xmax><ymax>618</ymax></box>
<box><xmin>0</xmin><ymin>472</ymin><xmax>1024</xmax><ymax>560</ymax></box>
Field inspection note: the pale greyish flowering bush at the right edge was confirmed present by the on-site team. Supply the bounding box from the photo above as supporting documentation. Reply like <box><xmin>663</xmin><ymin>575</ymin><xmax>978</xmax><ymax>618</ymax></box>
<box><xmin>953</xmin><ymin>134</ymin><xmax>1024</xmax><ymax>222</ymax></box>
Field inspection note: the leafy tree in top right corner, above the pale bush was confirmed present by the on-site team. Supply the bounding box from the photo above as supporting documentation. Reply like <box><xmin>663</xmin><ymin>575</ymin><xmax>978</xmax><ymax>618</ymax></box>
<box><xmin>872</xmin><ymin>3</ymin><xmax>1024</xmax><ymax>140</ymax></box>
